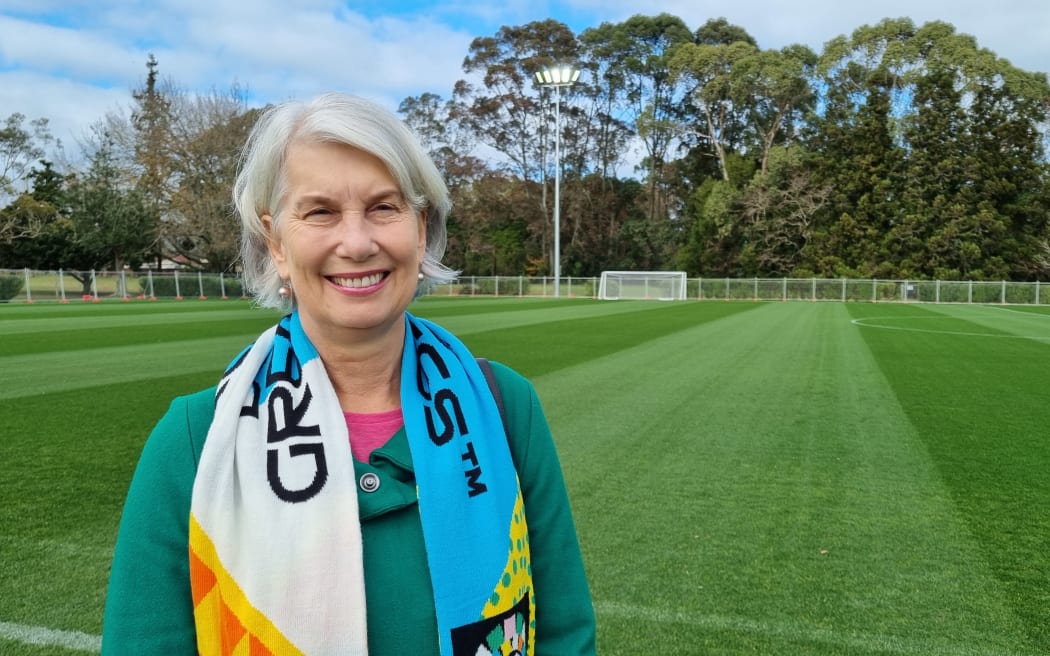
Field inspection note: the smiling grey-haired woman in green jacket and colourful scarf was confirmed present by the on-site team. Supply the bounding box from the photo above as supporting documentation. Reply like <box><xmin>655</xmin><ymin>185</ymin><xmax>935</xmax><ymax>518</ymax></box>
<box><xmin>102</xmin><ymin>94</ymin><xmax>594</xmax><ymax>656</ymax></box>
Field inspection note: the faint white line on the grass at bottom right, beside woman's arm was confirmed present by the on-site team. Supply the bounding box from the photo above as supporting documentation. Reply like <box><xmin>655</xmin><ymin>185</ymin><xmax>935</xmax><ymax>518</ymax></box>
<box><xmin>594</xmin><ymin>601</ymin><xmax>1034</xmax><ymax>656</ymax></box>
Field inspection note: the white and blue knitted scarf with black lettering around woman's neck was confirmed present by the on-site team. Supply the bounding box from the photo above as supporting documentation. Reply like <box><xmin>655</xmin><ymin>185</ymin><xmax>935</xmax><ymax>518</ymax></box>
<box><xmin>189</xmin><ymin>313</ymin><xmax>536</xmax><ymax>656</ymax></box>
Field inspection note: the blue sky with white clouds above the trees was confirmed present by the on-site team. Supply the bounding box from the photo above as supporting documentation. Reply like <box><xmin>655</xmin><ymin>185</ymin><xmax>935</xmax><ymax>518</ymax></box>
<box><xmin>0</xmin><ymin>0</ymin><xmax>1050</xmax><ymax>157</ymax></box>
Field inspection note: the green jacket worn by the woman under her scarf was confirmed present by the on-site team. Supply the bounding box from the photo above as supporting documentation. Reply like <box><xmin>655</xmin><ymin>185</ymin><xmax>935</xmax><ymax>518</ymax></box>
<box><xmin>102</xmin><ymin>362</ymin><xmax>595</xmax><ymax>656</ymax></box>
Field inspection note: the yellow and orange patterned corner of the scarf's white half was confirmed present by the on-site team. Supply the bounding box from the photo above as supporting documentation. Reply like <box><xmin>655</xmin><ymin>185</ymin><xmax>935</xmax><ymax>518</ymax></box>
<box><xmin>190</xmin><ymin>515</ymin><xmax>302</xmax><ymax>656</ymax></box>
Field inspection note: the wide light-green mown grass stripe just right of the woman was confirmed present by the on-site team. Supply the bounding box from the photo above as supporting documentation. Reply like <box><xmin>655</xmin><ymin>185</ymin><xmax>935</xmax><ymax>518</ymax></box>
<box><xmin>536</xmin><ymin>304</ymin><xmax>1023</xmax><ymax>656</ymax></box>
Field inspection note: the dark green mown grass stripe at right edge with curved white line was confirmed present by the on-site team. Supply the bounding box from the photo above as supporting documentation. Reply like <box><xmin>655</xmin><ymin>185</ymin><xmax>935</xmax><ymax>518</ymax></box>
<box><xmin>851</xmin><ymin>305</ymin><xmax>1050</xmax><ymax>651</ymax></box>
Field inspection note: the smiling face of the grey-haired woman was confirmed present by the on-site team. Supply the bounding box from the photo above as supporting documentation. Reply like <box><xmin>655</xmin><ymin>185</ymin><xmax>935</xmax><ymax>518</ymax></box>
<box><xmin>263</xmin><ymin>143</ymin><xmax>426</xmax><ymax>348</ymax></box>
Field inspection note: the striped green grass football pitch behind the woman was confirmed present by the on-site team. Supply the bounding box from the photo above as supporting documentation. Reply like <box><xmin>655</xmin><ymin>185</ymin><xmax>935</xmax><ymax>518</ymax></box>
<box><xmin>0</xmin><ymin>298</ymin><xmax>1050</xmax><ymax>656</ymax></box>
